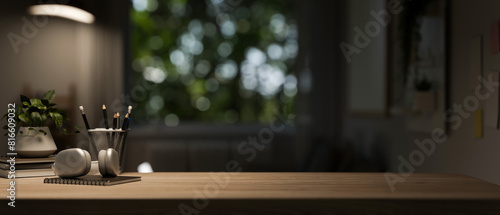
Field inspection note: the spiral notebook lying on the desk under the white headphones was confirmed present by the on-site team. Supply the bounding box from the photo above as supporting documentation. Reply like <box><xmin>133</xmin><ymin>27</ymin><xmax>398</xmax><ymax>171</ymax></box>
<box><xmin>43</xmin><ymin>175</ymin><xmax>141</xmax><ymax>186</ymax></box>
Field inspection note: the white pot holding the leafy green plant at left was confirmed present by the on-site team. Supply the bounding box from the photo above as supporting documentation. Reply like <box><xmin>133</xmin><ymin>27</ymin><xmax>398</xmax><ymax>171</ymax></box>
<box><xmin>16</xmin><ymin>126</ymin><xmax>57</xmax><ymax>157</ymax></box>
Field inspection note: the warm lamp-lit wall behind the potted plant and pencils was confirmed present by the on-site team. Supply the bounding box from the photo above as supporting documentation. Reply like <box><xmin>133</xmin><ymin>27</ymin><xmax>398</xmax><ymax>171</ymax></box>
<box><xmin>0</xmin><ymin>1</ymin><xmax>126</xmax><ymax>154</ymax></box>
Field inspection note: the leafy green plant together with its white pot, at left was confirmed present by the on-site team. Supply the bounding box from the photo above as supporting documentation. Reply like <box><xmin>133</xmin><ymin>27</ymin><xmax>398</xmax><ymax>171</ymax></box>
<box><xmin>4</xmin><ymin>90</ymin><xmax>71</xmax><ymax>157</ymax></box>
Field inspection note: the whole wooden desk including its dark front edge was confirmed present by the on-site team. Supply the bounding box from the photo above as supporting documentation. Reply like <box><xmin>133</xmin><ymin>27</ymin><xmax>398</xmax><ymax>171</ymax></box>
<box><xmin>0</xmin><ymin>172</ymin><xmax>500</xmax><ymax>214</ymax></box>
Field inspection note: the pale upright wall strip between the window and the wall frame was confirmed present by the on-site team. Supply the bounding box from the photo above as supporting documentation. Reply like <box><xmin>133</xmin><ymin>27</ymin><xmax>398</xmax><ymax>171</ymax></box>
<box><xmin>344</xmin><ymin>0</ymin><xmax>387</xmax><ymax>114</ymax></box>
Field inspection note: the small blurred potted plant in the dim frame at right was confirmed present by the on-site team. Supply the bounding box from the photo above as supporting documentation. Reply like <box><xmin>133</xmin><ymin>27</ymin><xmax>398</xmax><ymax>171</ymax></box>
<box><xmin>413</xmin><ymin>77</ymin><xmax>435</xmax><ymax>111</ymax></box>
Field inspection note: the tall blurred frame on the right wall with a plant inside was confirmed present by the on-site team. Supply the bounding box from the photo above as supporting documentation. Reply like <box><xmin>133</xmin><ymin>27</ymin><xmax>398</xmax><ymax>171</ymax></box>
<box><xmin>389</xmin><ymin>0</ymin><xmax>449</xmax><ymax>133</ymax></box>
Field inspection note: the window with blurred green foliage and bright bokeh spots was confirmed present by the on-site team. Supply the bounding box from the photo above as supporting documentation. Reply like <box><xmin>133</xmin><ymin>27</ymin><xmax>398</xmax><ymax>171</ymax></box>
<box><xmin>131</xmin><ymin>0</ymin><xmax>298</xmax><ymax>126</ymax></box>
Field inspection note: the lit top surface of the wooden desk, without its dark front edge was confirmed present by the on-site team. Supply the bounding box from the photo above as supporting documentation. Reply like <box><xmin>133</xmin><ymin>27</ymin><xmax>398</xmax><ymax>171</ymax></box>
<box><xmin>0</xmin><ymin>172</ymin><xmax>500</xmax><ymax>214</ymax></box>
